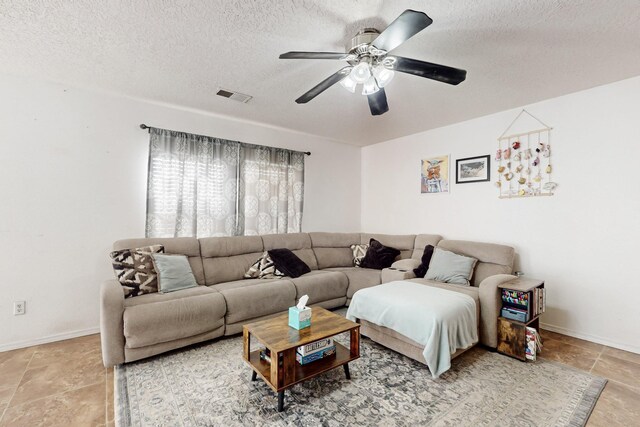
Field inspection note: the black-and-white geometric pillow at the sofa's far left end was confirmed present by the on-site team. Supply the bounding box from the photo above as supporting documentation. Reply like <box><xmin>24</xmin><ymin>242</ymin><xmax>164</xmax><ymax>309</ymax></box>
<box><xmin>110</xmin><ymin>245</ymin><xmax>164</xmax><ymax>298</ymax></box>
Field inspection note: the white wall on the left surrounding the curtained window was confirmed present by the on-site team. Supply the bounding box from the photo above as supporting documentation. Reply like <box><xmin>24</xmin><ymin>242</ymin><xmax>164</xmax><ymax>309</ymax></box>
<box><xmin>0</xmin><ymin>75</ymin><xmax>360</xmax><ymax>351</ymax></box>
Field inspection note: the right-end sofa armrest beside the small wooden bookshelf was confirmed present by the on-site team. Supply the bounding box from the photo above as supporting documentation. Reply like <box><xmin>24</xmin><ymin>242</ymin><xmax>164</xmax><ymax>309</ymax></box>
<box><xmin>478</xmin><ymin>274</ymin><xmax>516</xmax><ymax>348</ymax></box>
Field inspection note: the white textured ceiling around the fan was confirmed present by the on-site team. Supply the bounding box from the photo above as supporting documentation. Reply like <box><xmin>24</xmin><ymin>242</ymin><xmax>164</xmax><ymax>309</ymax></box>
<box><xmin>0</xmin><ymin>0</ymin><xmax>640</xmax><ymax>145</ymax></box>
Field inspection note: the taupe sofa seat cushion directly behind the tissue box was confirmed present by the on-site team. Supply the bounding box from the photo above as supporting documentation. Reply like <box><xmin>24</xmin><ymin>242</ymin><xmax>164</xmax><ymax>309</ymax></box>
<box><xmin>291</xmin><ymin>270</ymin><xmax>349</xmax><ymax>305</ymax></box>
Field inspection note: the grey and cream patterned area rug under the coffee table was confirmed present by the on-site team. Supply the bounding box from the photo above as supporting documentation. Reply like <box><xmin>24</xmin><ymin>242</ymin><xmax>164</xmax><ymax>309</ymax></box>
<box><xmin>115</xmin><ymin>337</ymin><xmax>606</xmax><ymax>426</ymax></box>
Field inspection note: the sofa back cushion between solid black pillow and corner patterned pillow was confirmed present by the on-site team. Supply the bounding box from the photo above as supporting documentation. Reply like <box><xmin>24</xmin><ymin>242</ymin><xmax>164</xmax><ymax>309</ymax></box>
<box><xmin>309</xmin><ymin>233</ymin><xmax>360</xmax><ymax>270</ymax></box>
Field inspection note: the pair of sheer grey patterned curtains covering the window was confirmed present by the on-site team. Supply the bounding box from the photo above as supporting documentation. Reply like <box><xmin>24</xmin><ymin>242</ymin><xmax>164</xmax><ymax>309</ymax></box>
<box><xmin>146</xmin><ymin>128</ymin><xmax>304</xmax><ymax>237</ymax></box>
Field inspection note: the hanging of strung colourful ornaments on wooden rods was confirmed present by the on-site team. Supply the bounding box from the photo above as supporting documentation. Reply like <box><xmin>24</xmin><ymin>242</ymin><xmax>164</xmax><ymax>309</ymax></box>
<box><xmin>496</xmin><ymin>109</ymin><xmax>558</xmax><ymax>199</ymax></box>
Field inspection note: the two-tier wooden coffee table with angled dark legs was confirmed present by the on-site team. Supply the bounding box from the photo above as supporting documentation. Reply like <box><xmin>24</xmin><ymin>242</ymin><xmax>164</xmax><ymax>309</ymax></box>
<box><xmin>242</xmin><ymin>307</ymin><xmax>360</xmax><ymax>412</ymax></box>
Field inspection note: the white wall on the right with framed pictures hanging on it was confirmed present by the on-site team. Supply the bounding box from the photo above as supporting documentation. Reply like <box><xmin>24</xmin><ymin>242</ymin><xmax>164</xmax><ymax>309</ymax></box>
<box><xmin>361</xmin><ymin>77</ymin><xmax>640</xmax><ymax>353</ymax></box>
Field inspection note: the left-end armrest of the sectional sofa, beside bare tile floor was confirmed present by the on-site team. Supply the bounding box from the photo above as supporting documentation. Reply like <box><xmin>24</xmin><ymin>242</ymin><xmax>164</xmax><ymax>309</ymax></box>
<box><xmin>100</xmin><ymin>279</ymin><xmax>124</xmax><ymax>368</ymax></box>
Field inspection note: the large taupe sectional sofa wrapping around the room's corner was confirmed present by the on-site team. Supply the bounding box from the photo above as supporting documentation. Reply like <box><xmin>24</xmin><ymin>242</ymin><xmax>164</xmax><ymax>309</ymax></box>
<box><xmin>100</xmin><ymin>233</ymin><xmax>514</xmax><ymax>367</ymax></box>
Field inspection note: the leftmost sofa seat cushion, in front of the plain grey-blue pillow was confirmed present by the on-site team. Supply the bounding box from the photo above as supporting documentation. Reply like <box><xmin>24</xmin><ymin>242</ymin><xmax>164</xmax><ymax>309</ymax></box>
<box><xmin>123</xmin><ymin>286</ymin><xmax>226</xmax><ymax>348</ymax></box>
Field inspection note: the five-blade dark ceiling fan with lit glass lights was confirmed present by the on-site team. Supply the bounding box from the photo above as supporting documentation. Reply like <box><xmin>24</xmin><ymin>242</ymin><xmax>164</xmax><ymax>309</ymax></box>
<box><xmin>280</xmin><ymin>9</ymin><xmax>467</xmax><ymax>116</ymax></box>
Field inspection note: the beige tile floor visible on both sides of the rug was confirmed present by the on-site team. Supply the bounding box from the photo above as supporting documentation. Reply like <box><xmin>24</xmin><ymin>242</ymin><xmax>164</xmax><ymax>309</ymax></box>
<box><xmin>0</xmin><ymin>331</ymin><xmax>640</xmax><ymax>427</ymax></box>
